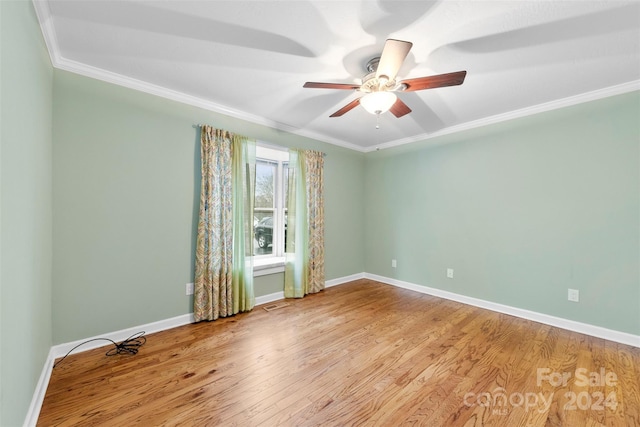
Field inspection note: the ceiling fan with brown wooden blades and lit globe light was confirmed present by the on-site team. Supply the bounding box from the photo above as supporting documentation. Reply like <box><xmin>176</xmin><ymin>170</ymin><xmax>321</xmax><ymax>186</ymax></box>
<box><xmin>303</xmin><ymin>39</ymin><xmax>467</xmax><ymax>117</ymax></box>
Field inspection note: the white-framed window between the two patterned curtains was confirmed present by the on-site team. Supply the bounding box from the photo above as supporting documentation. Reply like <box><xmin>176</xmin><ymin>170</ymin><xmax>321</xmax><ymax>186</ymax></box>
<box><xmin>253</xmin><ymin>145</ymin><xmax>289</xmax><ymax>267</ymax></box>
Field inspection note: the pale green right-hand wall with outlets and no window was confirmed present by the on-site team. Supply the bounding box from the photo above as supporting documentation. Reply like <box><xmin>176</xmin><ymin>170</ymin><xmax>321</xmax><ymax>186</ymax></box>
<box><xmin>365</xmin><ymin>92</ymin><xmax>640</xmax><ymax>335</ymax></box>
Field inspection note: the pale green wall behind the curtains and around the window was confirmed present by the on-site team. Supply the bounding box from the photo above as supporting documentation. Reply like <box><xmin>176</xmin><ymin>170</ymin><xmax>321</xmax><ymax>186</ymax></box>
<box><xmin>53</xmin><ymin>70</ymin><xmax>364</xmax><ymax>343</ymax></box>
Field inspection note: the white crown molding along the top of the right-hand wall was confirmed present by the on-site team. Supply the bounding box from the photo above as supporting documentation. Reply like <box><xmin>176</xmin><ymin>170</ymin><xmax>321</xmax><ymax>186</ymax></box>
<box><xmin>365</xmin><ymin>80</ymin><xmax>640</xmax><ymax>153</ymax></box>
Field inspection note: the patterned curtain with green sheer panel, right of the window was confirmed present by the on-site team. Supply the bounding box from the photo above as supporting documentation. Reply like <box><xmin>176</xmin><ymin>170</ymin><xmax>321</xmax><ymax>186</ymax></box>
<box><xmin>284</xmin><ymin>150</ymin><xmax>324</xmax><ymax>298</ymax></box>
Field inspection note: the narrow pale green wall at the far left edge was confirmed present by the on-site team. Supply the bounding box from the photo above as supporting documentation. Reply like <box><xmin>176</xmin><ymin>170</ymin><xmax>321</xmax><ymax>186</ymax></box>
<box><xmin>0</xmin><ymin>1</ymin><xmax>53</xmax><ymax>426</ymax></box>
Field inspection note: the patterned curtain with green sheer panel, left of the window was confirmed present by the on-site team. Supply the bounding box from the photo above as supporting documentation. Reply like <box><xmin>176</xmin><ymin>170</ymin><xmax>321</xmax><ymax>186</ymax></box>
<box><xmin>193</xmin><ymin>126</ymin><xmax>255</xmax><ymax>321</ymax></box>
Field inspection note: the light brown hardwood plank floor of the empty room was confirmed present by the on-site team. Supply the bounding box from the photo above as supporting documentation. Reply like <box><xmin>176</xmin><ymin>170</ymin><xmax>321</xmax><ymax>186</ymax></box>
<box><xmin>38</xmin><ymin>280</ymin><xmax>640</xmax><ymax>427</ymax></box>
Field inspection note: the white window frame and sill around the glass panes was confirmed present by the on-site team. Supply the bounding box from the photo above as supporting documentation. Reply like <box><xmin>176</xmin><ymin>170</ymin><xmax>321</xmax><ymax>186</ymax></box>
<box><xmin>253</xmin><ymin>142</ymin><xmax>289</xmax><ymax>276</ymax></box>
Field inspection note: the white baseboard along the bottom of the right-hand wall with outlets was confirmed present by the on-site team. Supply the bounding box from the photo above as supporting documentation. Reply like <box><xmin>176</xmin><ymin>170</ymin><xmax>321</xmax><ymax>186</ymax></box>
<box><xmin>365</xmin><ymin>273</ymin><xmax>640</xmax><ymax>348</ymax></box>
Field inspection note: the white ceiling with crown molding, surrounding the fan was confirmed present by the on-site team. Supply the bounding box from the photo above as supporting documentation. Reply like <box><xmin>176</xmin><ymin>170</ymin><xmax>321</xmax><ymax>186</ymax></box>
<box><xmin>34</xmin><ymin>0</ymin><xmax>640</xmax><ymax>151</ymax></box>
